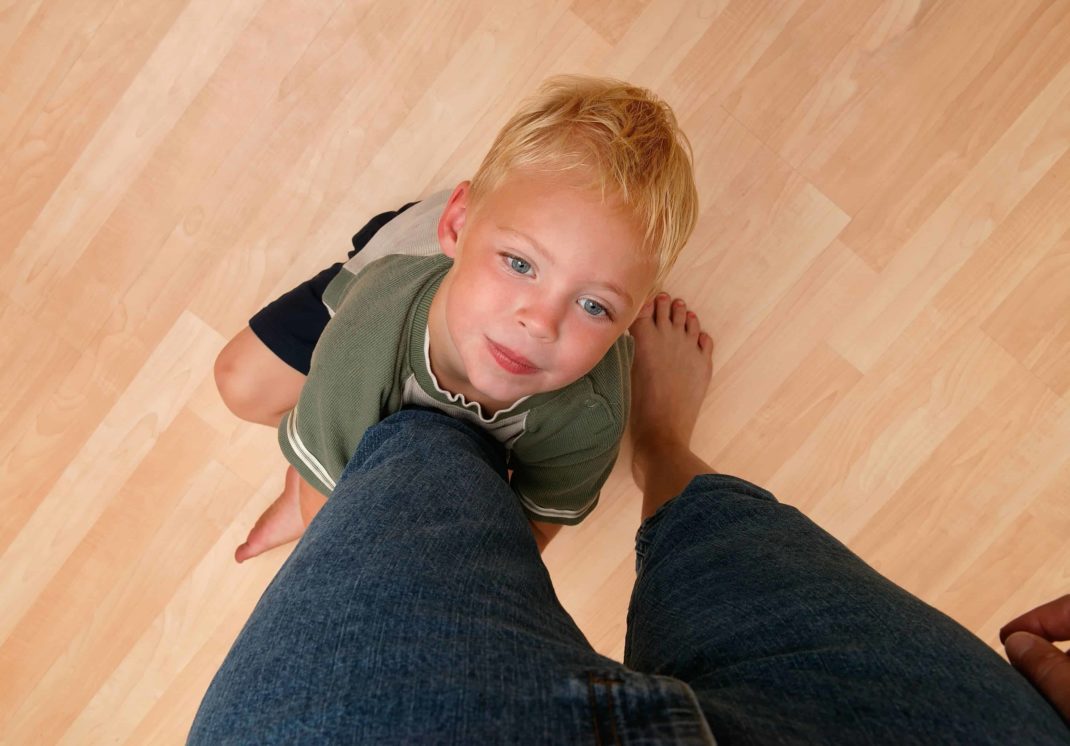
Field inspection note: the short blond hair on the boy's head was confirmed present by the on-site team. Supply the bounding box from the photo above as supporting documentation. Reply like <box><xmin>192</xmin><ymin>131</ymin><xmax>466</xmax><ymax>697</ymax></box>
<box><xmin>470</xmin><ymin>75</ymin><xmax>699</xmax><ymax>285</ymax></box>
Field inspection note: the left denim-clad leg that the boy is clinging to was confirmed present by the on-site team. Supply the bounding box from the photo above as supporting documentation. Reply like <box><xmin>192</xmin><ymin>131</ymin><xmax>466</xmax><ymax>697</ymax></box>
<box><xmin>189</xmin><ymin>410</ymin><xmax>712</xmax><ymax>744</ymax></box>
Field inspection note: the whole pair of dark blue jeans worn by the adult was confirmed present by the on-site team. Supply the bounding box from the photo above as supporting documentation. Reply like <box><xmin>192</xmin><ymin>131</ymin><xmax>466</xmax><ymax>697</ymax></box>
<box><xmin>189</xmin><ymin>410</ymin><xmax>1070</xmax><ymax>744</ymax></box>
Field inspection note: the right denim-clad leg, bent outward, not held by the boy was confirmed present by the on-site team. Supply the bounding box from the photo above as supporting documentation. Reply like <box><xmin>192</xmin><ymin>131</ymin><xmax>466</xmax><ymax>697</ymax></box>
<box><xmin>625</xmin><ymin>475</ymin><xmax>1070</xmax><ymax>744</ymax></box>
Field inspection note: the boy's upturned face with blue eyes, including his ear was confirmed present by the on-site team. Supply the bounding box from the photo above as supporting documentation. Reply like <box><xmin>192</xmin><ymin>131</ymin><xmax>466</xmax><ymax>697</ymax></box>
<box><xmin>431</xmin><ymin>172</ymin><xmax>655</xmax><ymax>409</ymax></box>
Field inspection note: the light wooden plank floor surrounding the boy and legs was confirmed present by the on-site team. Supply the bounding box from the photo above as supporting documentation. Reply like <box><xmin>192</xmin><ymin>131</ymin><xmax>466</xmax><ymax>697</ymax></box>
<box><xmin>0</xmin><ymin>0</ymin><xmax>1070</xmax><ymax>744</ymax></box>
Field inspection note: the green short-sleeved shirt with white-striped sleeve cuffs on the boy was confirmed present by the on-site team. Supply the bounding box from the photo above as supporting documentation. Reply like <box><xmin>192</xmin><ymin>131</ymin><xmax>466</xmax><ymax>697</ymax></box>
<box><xmin>278</xmin><ymin>254</ymin><xmax>632</xmax><ymax>524</ymax></box>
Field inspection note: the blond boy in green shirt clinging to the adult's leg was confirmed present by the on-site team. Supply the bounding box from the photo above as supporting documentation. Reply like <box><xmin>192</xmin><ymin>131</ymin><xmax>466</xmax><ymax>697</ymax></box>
<box><xmin>216</xmin><ymin>76</ymin><xmax>698</xmax><ymax>562</ymax></box>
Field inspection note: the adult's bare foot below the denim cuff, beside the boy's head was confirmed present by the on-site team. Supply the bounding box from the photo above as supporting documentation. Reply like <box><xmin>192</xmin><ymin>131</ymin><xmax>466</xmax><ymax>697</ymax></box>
<box><xmin>629</xmin><ymin>293</ymin><xmax>714</xmax><ymax>517</ymax></box>
